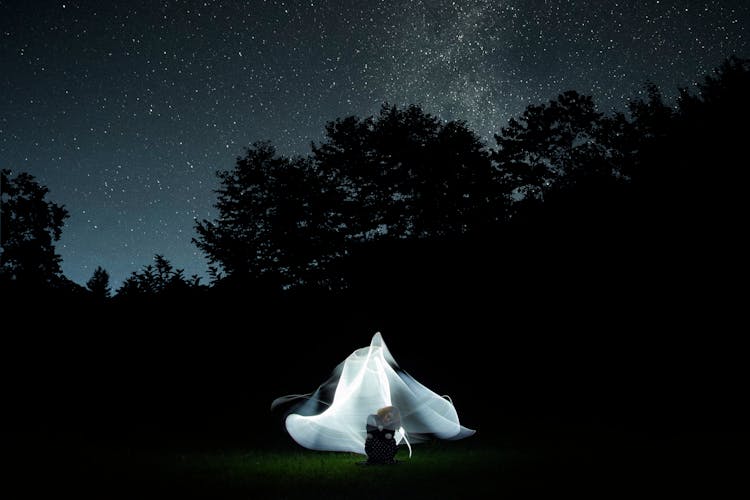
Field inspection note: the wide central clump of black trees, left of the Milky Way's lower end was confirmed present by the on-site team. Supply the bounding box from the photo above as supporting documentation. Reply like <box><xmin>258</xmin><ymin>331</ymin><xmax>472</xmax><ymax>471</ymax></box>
<box><xmin>194</xmin><ymin>105</ymin><xmax>507</xmax><ymax>289</ymax></box>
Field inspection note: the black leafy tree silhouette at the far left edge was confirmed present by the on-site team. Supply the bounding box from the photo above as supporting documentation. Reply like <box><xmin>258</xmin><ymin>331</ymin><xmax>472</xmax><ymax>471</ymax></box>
<box><xmin>0</xmin><ymin>170</ymin><xmax>68</xmax><ymax>287</ymax></box>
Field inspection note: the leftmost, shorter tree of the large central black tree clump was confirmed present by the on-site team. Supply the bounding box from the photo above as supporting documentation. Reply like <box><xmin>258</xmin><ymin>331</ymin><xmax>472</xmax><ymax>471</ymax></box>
<box><xmin>193</xmin><ymin>142</ymin><xmax>343</xmax><ymax>288</ymax></box>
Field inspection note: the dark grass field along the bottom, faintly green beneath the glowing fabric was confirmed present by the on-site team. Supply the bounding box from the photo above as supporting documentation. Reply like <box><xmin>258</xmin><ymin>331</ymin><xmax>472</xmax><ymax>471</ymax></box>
<box><xmin>5</xmin><ymin>433</ymin><xmax>747</xmax><ymax>499</ymax></box>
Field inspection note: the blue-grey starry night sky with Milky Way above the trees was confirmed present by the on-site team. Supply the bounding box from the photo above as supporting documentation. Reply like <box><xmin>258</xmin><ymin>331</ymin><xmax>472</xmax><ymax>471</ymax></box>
<box><xmin>0</xmin><ymin>0</ymin><xmax>750</xmax><ymax>289</ymax></box>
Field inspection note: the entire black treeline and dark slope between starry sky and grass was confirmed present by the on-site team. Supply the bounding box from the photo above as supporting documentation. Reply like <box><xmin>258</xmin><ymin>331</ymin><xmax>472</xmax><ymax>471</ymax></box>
<box><xmin>0</xmin><ymin>58</ymin><xmax>750</xmax><ymax>448</ymax></box>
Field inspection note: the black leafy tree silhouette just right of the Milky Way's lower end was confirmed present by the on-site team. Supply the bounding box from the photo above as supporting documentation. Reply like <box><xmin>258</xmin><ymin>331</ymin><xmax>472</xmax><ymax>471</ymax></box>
<box><xmin>493</xmin><ymin>91</ymin><xmax>636</xmax><ymax>238</ymax></box>
